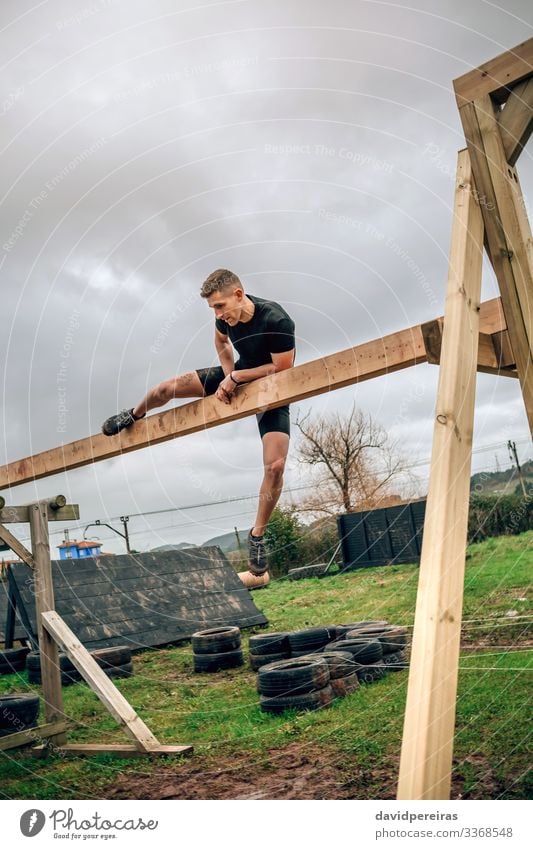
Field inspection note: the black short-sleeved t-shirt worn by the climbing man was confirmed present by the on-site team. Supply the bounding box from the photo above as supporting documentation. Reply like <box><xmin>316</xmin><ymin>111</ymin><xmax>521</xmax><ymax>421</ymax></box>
<box><xmin>215</xmin><ymin>295</ymin><xmax>295</xmax><ymax>369</ymax></box>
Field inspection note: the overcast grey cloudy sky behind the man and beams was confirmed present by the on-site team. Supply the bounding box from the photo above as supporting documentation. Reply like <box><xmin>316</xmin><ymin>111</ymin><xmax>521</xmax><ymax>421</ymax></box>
<box><xmin>0</xmin><ymin>0</ymin><xmax>533</xmax><ymax>552</ymax></box>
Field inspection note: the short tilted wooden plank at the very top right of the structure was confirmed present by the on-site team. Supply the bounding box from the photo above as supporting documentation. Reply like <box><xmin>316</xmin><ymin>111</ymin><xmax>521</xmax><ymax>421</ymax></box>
<box><xmin>453</xmin><ymin>38</ymin><xmax>533</xmax><ymax>108</ymax></box>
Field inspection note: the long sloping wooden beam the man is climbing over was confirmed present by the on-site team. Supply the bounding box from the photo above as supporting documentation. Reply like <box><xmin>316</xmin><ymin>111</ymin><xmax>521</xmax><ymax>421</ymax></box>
<box><xmin>0</xmin><ymin>298</ymin><xmax>506</xmax><ymax>494</ymax></box>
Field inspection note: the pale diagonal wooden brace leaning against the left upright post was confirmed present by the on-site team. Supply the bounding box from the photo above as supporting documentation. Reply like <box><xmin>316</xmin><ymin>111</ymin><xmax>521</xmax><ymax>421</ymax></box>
<box><xmin>41</xmin><ymin>610</ymin><xmax>159</xmax><ymax>752</ymax></box>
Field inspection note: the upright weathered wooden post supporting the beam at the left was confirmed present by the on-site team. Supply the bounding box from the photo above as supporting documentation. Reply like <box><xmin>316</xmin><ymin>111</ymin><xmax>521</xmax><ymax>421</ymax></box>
<box><xmin>28</xmin><ymin>502</ymin><xmax>67</xmax><ymax>745</ymax></box>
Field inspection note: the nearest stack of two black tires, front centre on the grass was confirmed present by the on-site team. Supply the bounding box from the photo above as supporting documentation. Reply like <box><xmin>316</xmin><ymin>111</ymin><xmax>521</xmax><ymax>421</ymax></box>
<box><xmin>257</xmin><ymin>655</ymin><xmax>334</xmax><ymax>714</ymax></box>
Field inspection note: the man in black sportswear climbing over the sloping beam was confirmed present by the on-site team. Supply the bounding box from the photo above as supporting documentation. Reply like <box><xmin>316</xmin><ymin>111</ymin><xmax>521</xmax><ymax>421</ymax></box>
<box><xmin>102</xmin><ymin>268</ymin><xmax>295</xmax><ymax>576</ymax></box>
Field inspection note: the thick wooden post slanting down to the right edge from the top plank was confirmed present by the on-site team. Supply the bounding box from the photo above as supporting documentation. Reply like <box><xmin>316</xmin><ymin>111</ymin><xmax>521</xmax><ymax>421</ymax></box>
<box><xmin>460</xmin><ymin>96</ymin><xmax>533</xmax><ymax>433</ymax></box>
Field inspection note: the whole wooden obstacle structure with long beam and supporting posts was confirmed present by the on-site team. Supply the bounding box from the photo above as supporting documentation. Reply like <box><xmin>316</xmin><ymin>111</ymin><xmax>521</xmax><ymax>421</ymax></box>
<box><xmin>0</xmin><ymin>39</ymin><xmax>533</xmax><ymax>799</ymax></box>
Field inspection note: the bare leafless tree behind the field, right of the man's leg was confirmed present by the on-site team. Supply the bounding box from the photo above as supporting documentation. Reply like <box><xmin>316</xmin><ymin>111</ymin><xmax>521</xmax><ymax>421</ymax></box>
<box><xmin>295</xmin><ymin>404</ymin><xmax>409</xmax><ymax>515</ymax></box>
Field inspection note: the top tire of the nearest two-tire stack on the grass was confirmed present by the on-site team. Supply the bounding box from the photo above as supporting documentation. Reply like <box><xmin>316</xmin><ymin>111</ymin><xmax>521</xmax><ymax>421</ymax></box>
<box><xmin>257</xmin><ymin>657</ymin><xmax>329</xmax><ymax>697</ymax></box>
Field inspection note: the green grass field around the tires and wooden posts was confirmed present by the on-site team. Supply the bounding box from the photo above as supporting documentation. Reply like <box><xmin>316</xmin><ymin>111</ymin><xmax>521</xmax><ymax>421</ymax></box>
<box><xmin>0</xmin><ymin>532</ymin><xmax>533</xmax><ymax>799</ymax></box>
